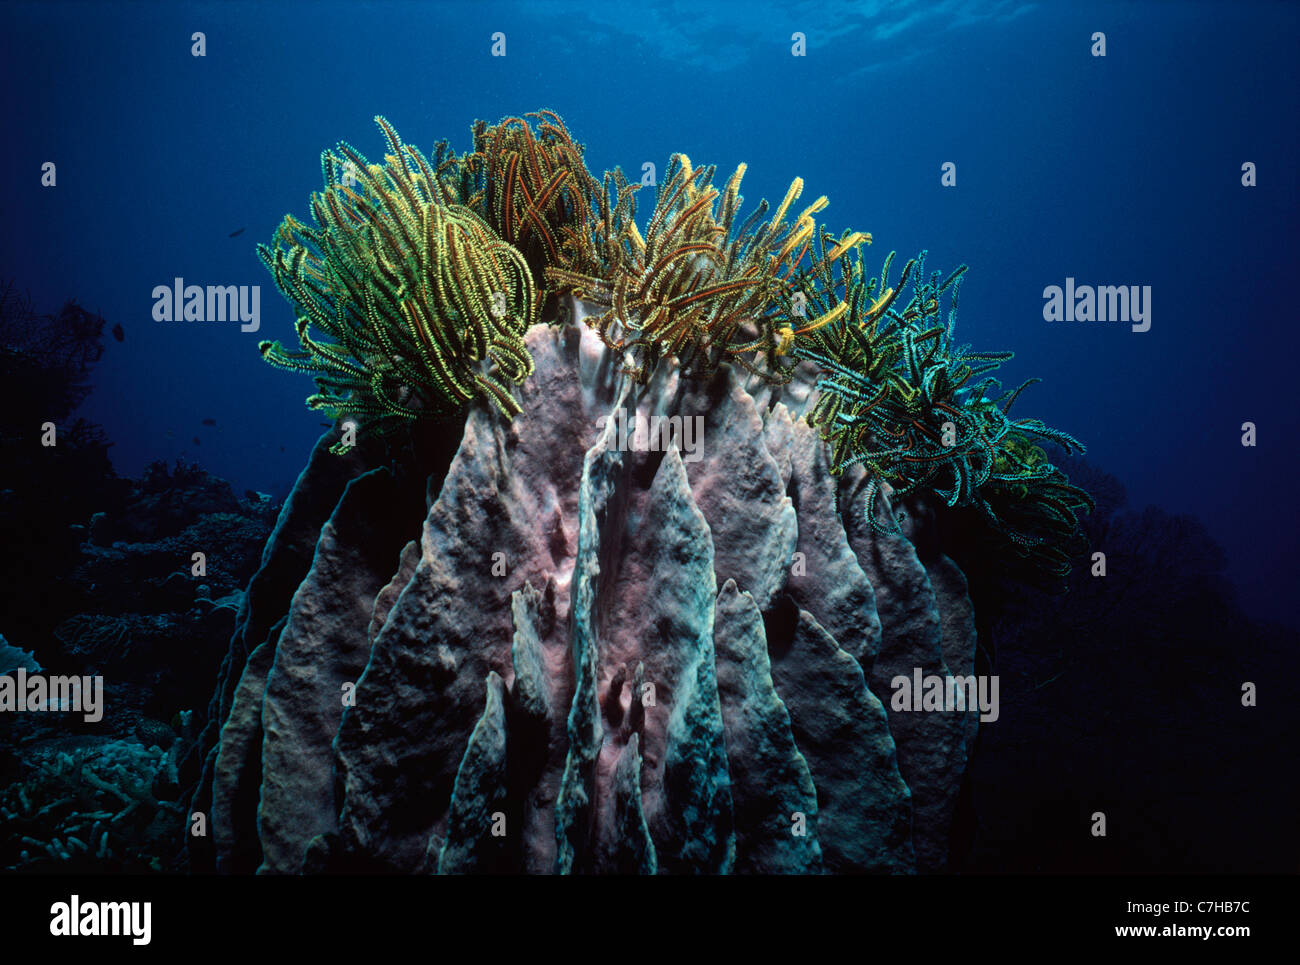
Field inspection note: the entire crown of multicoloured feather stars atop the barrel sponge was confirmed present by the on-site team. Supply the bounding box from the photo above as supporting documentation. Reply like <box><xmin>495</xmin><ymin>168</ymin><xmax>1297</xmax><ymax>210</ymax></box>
<box><xmin>259</xmin><ymin>112</ymin><xmax>1092</xmax><ymax>580</ymax></box>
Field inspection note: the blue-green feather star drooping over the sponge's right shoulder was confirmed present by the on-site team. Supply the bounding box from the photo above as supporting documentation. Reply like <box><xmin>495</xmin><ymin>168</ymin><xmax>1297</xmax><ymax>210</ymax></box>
<box><xmin>788</xmin><ymin>243</ymin><xmax>1092</xmax><ymax>577</ymax></box>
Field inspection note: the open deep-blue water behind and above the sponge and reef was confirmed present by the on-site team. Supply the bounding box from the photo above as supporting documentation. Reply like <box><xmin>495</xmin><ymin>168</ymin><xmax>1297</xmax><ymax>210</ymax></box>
<box><xmin>0</xmin><ymin>1</ymin><xmax>1300</xmax><ymax>626</ymax></box>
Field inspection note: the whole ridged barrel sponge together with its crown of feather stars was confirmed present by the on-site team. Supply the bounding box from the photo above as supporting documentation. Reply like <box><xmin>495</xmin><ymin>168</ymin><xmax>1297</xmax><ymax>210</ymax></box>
<box><xmin>215</xmin><ymin>112</ymin><xmax>1091</xmax><ymax>874</ymax></box>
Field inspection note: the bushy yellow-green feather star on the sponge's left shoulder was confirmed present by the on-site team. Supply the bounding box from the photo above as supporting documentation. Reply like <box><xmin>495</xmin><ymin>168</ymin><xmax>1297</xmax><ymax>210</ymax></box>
<box><xmin>259</xmin><ymin>117</ymin><xmax>537</xmax><ymax>451</ymax></box>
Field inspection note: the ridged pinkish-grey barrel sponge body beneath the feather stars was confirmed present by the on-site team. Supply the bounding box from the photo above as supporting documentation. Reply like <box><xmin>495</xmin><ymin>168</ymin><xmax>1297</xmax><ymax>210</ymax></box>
<box><xmin>191</xmin><ymin>317</ymin><xmax>975</xmax><ymax>873</ymax></box>
